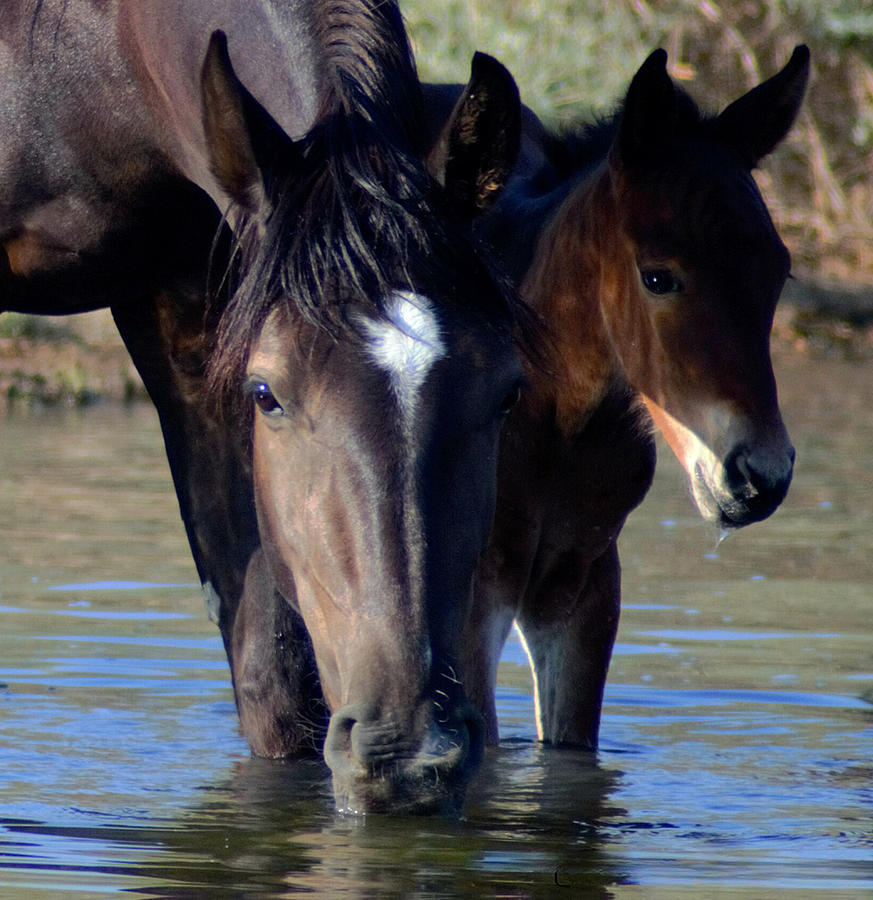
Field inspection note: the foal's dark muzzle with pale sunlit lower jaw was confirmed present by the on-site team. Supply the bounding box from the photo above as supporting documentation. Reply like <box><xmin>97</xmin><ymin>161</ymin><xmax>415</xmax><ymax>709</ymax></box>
<box><xmin>643</xmin><ymin>396</ymin><xmax>794</xmax><ymax>531</ymax></box>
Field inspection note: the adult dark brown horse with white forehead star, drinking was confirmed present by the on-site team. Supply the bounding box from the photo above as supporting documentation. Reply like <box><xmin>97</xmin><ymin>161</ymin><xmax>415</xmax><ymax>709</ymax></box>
<box><xmin>0</xmin><ymin>0</ymin><xmax>520</xmax><ymax>810</ymax></box>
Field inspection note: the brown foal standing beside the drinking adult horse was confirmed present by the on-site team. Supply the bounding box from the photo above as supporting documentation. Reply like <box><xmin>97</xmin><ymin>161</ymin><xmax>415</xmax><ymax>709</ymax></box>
<box><xmin>431</xmin><ymin>47</ymin><xmax>809</xmax><ymax>748</ymax></box>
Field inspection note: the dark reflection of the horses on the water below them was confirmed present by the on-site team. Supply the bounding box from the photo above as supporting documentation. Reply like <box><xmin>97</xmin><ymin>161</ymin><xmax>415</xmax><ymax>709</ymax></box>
<box><xmin>0</xmin><ymin>745</ymin><xmax>619</xmax><ymax>897</ymax></box>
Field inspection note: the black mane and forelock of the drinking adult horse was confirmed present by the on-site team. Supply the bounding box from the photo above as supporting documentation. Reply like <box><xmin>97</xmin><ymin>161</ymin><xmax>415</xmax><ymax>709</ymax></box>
<box><xmin>210</xmin><ymin>0</ymin><xmax>516</xmax><ymax>408</ymax></box>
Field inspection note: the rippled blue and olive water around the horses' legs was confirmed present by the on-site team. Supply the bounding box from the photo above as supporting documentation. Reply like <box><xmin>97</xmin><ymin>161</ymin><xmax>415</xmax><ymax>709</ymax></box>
<box><xmin>0</xmin><ymin>348</ymin><xmax>873</xmax><ymax>898</ymax></box>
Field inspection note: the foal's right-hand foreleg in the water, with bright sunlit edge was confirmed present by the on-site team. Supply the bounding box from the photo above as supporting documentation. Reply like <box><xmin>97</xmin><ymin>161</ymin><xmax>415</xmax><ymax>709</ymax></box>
<box><xmin>517</xmin><ymin>542</ymin><xmax>621</xmax><ymax>750</ymax></box>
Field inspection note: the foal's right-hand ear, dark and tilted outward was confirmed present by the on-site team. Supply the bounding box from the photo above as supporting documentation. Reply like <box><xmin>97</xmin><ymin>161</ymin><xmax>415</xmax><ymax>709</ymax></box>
<box><xmin>715</xmin><ymin>44</ymin><xmax>809</xmax><ymax>168</ymax></box>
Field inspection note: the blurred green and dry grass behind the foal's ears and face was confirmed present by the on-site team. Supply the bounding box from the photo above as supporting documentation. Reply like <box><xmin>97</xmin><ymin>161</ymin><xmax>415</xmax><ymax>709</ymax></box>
<box><xmin>400</xmin><ymin>0</ymin><xmax>873</xmax><ymax>285</ymax></box>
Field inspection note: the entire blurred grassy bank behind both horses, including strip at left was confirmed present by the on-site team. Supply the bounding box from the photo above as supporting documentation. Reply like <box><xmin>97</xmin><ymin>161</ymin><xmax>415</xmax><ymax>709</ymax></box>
<box><xmin>0</xmin><ymin>0</ymin><xmax>873</xmax><ymax>400</ymax></box>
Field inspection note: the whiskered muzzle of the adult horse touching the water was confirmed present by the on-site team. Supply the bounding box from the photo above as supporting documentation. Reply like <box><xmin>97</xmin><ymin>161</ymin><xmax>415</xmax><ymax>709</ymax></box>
<box><xmin>324</xmin><ymin>704</ymin><xmax>485</xmax><ymax>815</ymax></box>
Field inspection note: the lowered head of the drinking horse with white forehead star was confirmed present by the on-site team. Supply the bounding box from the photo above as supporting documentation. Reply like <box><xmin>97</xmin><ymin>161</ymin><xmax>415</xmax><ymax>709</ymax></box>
<box><xmin>204</xmin><ymin>33</ymin><xmax>521</xmax><ymax>811</ymax></box>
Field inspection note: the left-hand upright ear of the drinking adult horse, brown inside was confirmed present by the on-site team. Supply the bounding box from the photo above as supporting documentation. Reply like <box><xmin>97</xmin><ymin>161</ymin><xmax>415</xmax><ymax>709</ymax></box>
<box><xmin>200</xmin><ymin>31</ymin><xmax>292</xmax><ymax>215</ymax></box>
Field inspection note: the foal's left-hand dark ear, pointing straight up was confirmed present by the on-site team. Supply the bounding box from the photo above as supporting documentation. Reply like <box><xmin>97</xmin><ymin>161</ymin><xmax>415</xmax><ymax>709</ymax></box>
<box><xmin>613</xmin><ymin>49</ymin><xmax>677</xmax><ymax>164</ymax></box>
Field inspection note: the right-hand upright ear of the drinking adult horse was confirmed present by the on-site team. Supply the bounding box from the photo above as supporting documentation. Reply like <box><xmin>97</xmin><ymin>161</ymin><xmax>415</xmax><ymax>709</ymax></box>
<box><xmin>427</xmin><ymin>53</ymin><xmax>521</xmax><ymax>218</ymax></box>
